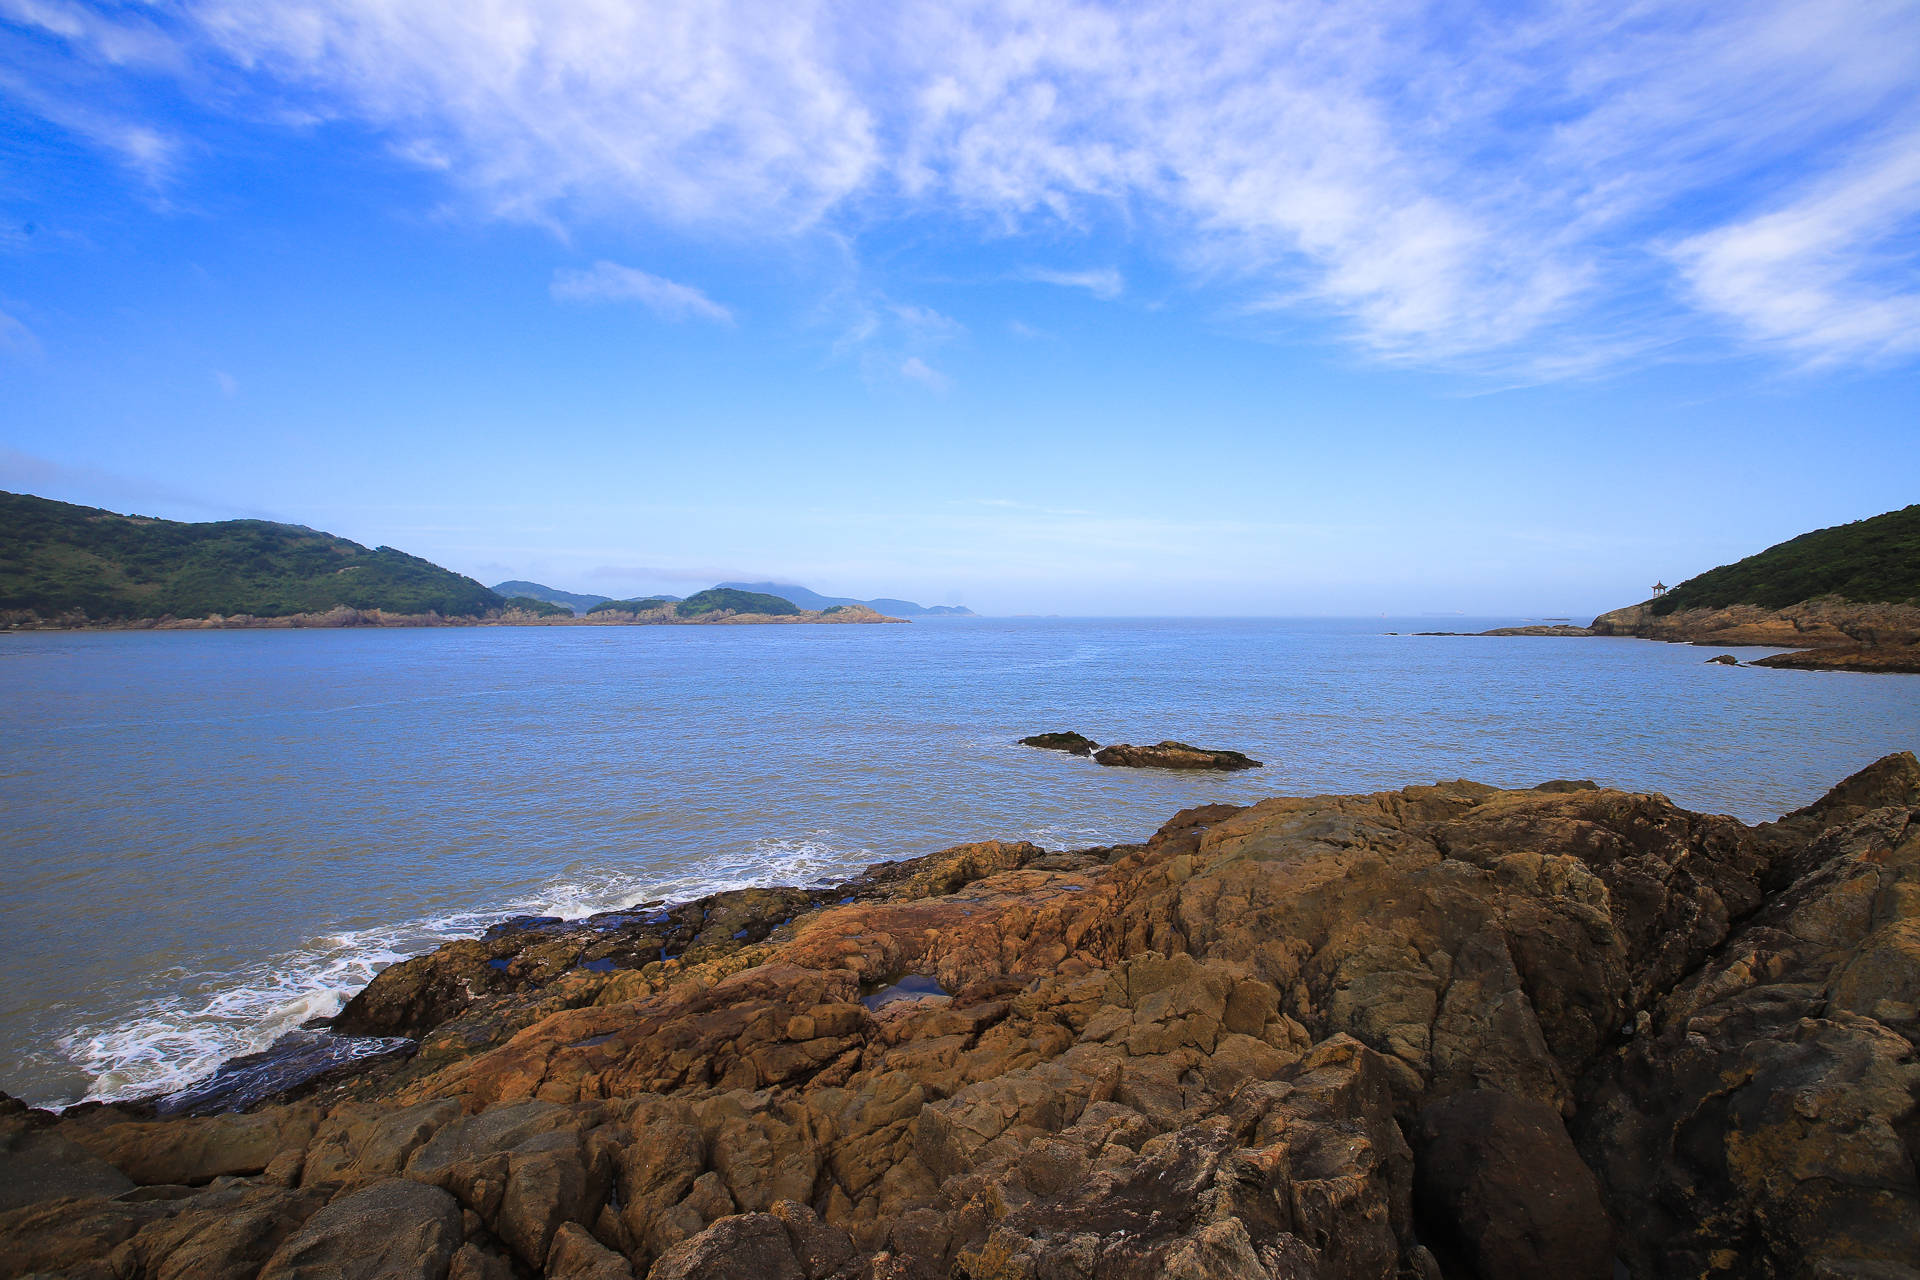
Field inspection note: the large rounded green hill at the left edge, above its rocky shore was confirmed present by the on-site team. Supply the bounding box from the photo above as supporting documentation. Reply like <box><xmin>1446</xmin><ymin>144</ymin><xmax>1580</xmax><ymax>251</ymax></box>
<box><xmin>0</xmin><ymin>493</ymin><xmax>505</xmax><ymax>622</ymax></box>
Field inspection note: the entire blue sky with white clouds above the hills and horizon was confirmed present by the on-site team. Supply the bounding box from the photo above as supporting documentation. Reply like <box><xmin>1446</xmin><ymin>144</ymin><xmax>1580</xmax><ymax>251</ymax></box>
<box><xmin>0</xmin><ymin>0</ymin><xmax>1920</xmax><ymax>614</ymax></box>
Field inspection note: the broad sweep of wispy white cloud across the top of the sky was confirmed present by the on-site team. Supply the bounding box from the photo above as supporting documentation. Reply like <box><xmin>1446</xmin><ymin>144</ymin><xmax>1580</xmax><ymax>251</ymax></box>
<box><xmin>11</xmin><ymin>0</ymin><xmax>1920</xmax><ymax>376</ymax></box>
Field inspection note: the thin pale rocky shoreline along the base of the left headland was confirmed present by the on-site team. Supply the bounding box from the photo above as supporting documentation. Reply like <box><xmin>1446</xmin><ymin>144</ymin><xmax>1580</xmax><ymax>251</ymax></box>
<box><xmin>0</xmin><ymin>604</ymin><xmax>908</xmax><ymax>631</ymax></box>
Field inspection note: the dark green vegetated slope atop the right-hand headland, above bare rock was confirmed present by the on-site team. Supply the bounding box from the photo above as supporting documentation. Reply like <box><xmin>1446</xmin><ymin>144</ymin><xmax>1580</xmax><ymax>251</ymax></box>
<box><xmin>1651</xmin><ymin>503</ymin><xmax>1920</xmax><ymax>616</ymax></box>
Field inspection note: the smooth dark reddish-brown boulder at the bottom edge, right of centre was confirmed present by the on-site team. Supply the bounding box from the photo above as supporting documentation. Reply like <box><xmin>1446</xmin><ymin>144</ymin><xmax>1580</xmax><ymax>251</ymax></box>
<box><xmin>1413</xmin><ymin>1090</ymin><xmax>1613</xmax><ymax>1280</ymax></box>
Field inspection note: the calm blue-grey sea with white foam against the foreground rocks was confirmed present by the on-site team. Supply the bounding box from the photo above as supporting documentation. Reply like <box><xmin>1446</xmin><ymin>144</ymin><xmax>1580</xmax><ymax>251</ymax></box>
<box><xmin>0</xmin><ymin>618</ymin><xmax>1920</xmax><ymax>1103</ymax></box>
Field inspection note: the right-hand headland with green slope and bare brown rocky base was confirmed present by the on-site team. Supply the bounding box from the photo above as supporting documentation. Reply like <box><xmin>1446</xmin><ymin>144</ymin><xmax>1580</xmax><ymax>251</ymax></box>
<box><xmin>1592</xmin><ymin>505</ymin><xmax>1920</xmax><ymax>672</ymax></box>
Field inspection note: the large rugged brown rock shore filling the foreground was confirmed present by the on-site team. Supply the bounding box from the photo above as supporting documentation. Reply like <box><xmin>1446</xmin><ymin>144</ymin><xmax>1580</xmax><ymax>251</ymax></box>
<box><xmin>0</xmin><ymin>752</ymin><xmax>1920</xmax><ymax>1280</ymax></box>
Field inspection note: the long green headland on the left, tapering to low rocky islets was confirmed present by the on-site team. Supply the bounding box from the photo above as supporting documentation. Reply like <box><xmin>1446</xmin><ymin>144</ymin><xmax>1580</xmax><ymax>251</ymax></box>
<box><xmin>0</xmin><ymin>493</ymin><xmax>900</xmax><ymax>631</ymax></box>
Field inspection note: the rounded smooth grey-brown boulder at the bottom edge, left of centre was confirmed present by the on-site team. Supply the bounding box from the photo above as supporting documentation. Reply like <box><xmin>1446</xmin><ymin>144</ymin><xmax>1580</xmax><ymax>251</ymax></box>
<box><xmin>259</xmin><ymin>1178</ymin><xmax>461</xmax><ymax>1280</ymax></box>
